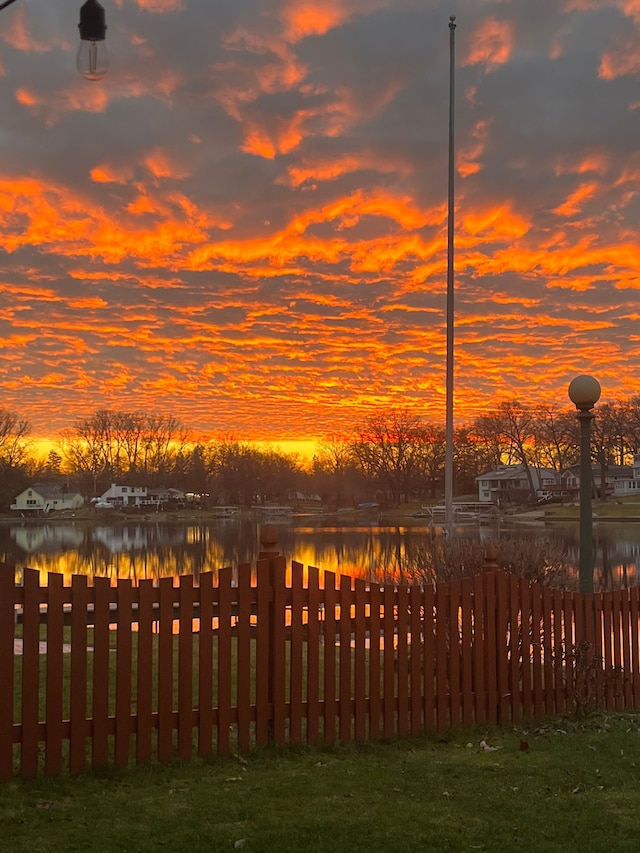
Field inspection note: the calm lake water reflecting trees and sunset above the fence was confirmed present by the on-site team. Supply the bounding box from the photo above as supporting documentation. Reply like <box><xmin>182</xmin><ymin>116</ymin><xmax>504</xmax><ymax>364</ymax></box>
<box><xmin>0</xmin><ymin>519</ymin><xmax>640</xmax><ymax>588</ymax></box>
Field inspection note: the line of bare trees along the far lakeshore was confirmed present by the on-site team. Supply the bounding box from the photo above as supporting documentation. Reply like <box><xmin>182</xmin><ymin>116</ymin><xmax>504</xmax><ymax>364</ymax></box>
<box><xmin>0</xmin><ymin>397</ymin><xmax>640</xmax><ymax>509</ymax></box>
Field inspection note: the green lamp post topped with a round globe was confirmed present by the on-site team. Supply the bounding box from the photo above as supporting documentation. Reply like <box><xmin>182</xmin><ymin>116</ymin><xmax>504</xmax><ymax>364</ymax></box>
<box><xmin>569</xmin><ymin>375</ymin><xmax>601</xmax><ymax>592</ymax></box>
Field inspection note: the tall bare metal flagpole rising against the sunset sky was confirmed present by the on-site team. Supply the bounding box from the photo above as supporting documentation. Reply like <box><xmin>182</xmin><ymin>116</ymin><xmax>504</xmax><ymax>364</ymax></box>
<box><xmin>444</xmin><ymin>15</ymin><xmax>456</xmax><ymax>533</ymax></box>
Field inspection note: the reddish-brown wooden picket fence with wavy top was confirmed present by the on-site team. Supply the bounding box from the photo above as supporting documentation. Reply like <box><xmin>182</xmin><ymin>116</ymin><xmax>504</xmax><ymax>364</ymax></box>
<box><xmin>0</xmin><ymin>556</ymin><xmax>640</xmax><ymax>781</ymax></box>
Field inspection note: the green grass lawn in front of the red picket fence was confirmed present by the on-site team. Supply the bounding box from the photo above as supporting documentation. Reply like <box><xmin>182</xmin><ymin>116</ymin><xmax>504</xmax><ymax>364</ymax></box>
<box><xmin>0</xmin><ymin>714</ymin><xmax>640</xmax><ymax>853</ymax></box>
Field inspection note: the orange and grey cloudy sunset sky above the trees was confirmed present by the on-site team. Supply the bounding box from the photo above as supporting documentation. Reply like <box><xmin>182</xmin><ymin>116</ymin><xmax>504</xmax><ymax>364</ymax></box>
<box><xmin>0</xmin><ymin>0</ymin><xmax>640</xmax><ymax>450</ymax></box>
